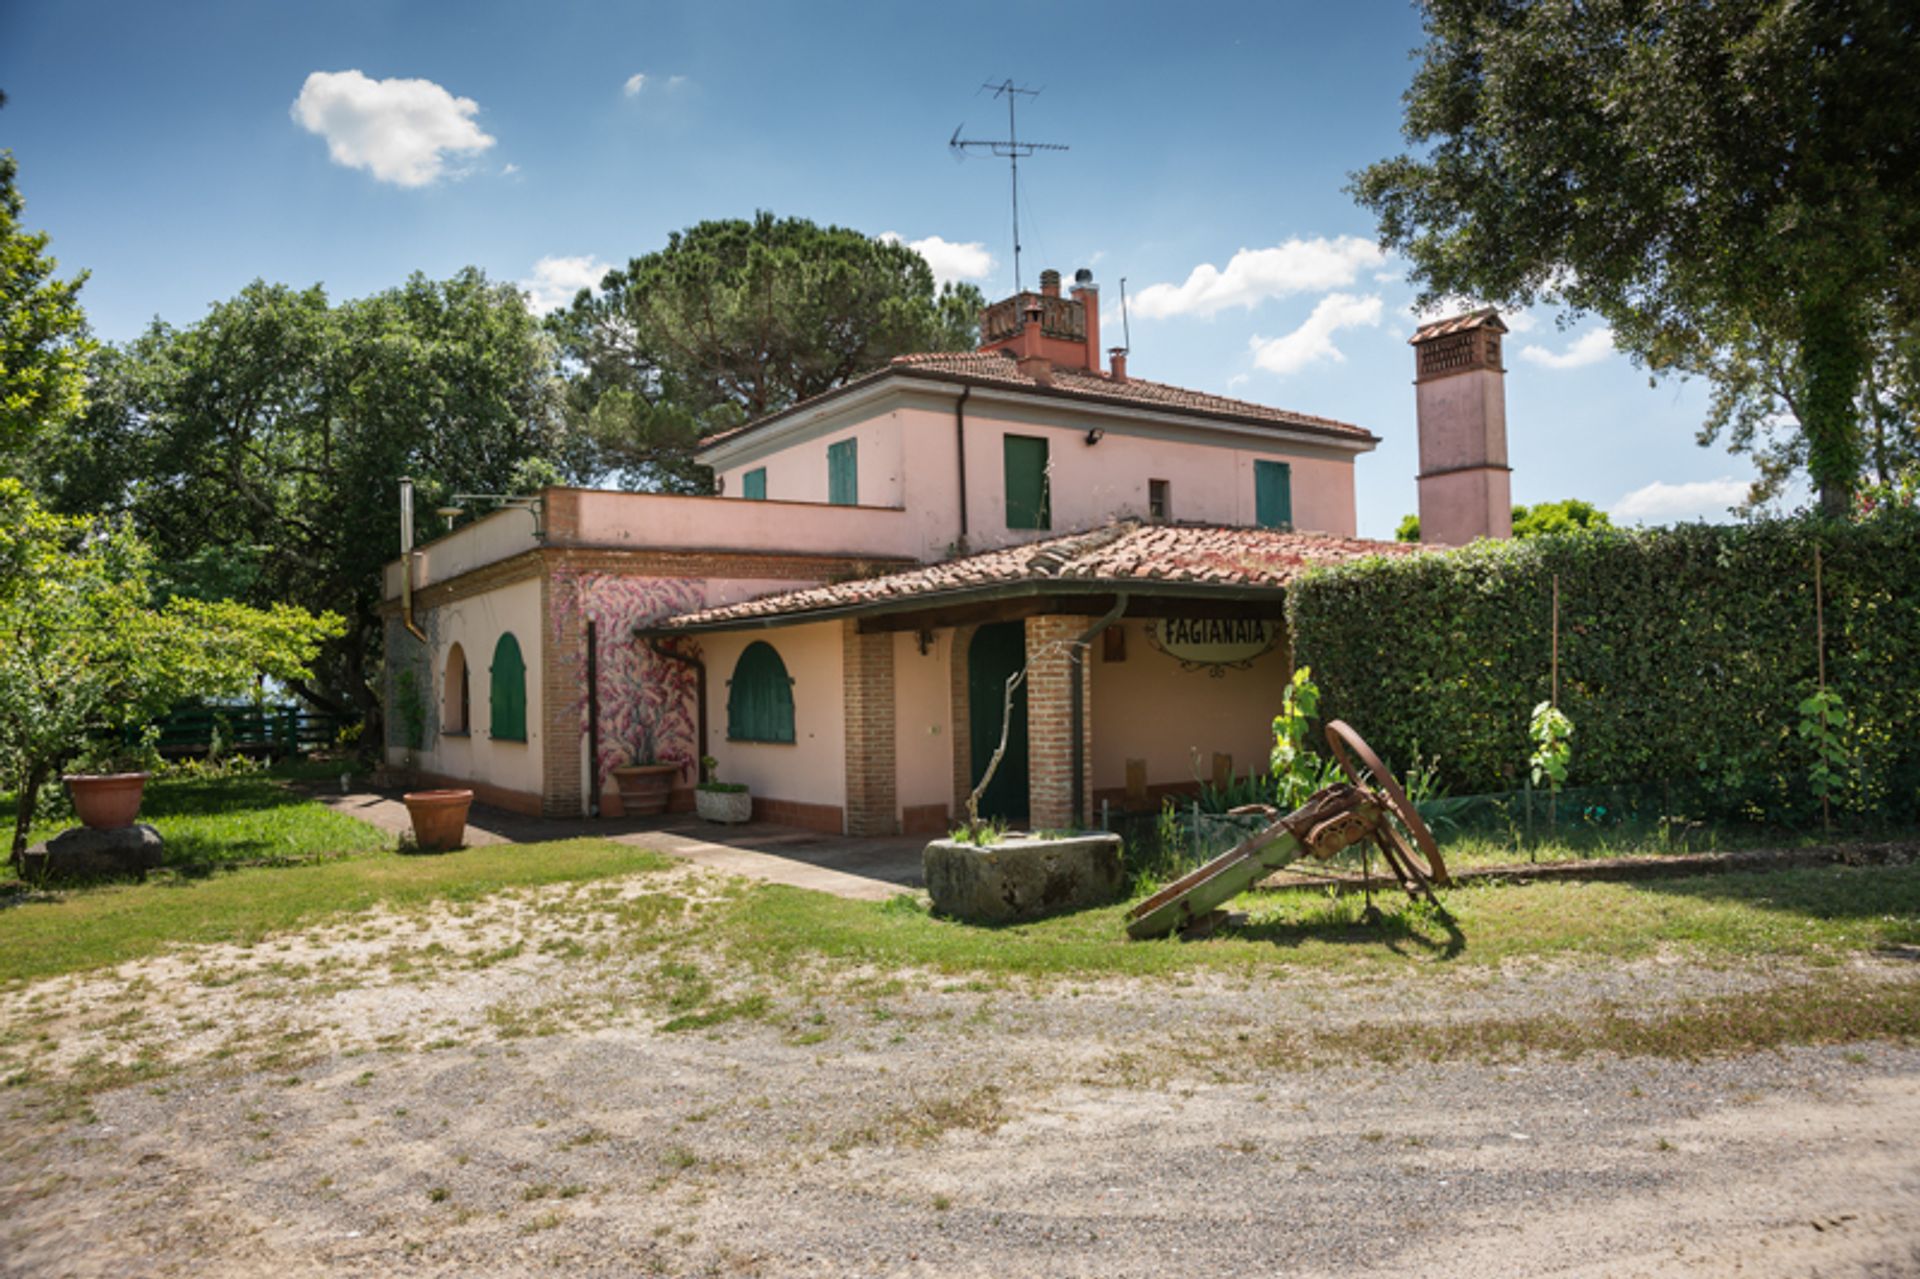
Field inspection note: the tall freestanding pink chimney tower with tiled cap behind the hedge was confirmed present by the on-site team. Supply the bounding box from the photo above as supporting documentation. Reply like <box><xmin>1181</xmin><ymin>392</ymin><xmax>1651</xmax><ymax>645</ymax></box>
<box><xmin>1411</xmin><ymin>307</ymin><xmax>1513</xmax><ymax>545</ymax></box>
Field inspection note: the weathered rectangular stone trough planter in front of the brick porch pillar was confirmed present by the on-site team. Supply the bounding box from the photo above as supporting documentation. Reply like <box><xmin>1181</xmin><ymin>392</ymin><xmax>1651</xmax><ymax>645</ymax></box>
<box><xmin>920</xmin><ymin>833</ymin><xmax>1127</xmax><ymax>924</ymax></box>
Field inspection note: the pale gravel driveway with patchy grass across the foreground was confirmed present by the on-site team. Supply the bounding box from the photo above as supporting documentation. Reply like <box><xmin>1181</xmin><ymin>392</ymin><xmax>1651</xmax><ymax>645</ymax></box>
<box><xmin>0</xmin><ymin>870</ymin><xmax>1920</xmax><ymax>1277</ymax></box>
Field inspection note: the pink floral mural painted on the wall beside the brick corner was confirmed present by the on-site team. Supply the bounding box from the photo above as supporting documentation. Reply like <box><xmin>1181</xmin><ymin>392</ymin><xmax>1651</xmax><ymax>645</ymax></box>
<box><xmin>551</xmin><ymin>568</ymin><xmax>707</xmax><ymax>795</ymax></box>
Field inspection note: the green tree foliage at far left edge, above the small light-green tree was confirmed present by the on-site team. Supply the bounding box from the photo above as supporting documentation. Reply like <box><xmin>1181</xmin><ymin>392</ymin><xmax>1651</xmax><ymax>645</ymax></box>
<box><xmin>0</xmin><ymin>133</ymin><xmax>92</xmax><ymax>463</ymax></box>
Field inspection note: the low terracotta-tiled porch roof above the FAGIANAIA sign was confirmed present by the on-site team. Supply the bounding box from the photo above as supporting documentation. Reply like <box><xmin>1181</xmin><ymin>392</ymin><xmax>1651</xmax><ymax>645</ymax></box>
<box><xmin>643</xmin><ymin>520</ymin><xmax>1421</xmax><ymax>636</ymax></box>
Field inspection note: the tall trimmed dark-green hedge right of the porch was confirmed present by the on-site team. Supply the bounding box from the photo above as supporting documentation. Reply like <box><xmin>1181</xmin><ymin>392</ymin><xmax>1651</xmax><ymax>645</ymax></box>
<box><xmin>1286</xmin><ymin>511</ymin><xmax>1920</xmax><ymax>820</ymax></box>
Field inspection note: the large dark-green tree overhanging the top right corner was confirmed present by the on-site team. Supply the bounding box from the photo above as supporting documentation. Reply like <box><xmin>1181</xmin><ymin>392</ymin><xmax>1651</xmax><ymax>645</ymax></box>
<box><xmin>1352</xmin><ymin>0</ymin><xmax>1920</xmax><ymax>515</ymax></box>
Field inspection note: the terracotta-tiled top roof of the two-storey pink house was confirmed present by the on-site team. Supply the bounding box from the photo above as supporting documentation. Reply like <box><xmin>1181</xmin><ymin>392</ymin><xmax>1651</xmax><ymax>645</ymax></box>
<box><xmin>701</xmin><ymin>350</ymin><xmax>1377</xmax><ymax>447</ymax></box>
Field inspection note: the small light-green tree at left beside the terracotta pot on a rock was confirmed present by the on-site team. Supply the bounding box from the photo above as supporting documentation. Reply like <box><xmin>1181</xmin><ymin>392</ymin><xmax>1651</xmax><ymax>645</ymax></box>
<box><xmin>0</xmin><ymin>478</ymin><xmax>340</xmax><ymax>866</ymax></box>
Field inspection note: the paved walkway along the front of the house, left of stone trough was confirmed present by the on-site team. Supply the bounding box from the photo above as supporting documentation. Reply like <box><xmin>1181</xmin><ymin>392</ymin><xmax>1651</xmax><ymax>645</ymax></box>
<box><xmin>315</xmin><ymin>791</ymin><xmax>927</xmax><ymax>901</ymax></box>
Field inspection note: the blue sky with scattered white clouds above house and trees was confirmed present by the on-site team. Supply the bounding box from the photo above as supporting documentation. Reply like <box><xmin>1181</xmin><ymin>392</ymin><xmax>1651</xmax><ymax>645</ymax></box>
<box><xmin>0</xmin><ymin>0</ymin><xmax>1781</xmax><ymax>536</ymax></box>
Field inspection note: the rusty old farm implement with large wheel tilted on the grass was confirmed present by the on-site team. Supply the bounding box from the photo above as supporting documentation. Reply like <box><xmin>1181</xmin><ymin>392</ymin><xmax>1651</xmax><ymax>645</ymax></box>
<box><xmin>1127</xmin><ymin>720</ymin><xmax>1450</xmax><ymax>939</ymax></box>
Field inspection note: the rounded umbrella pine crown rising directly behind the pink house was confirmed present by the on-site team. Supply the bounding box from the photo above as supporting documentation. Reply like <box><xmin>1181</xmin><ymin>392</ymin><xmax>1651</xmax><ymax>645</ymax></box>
<box><xmin>551</xmin><ymin>213</ymin><xmax>983</xmax><ymax>492</ymax></box>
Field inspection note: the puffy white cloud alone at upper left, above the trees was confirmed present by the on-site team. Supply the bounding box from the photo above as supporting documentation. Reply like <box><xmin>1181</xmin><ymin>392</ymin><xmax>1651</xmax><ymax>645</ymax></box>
<box><xmin>294</xmin><ymin>71</ymin><xmax>493</xmax><ymax>186</ymax></box>
